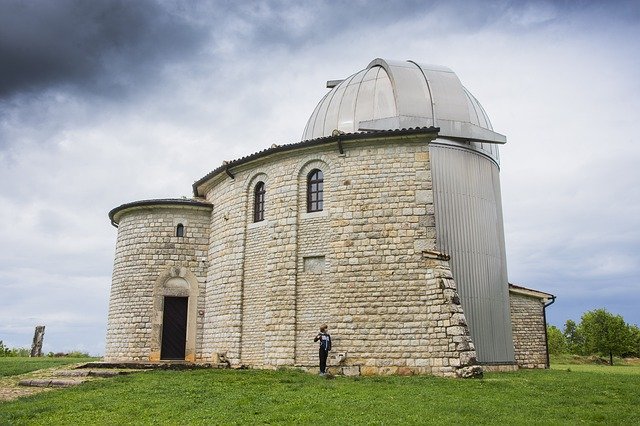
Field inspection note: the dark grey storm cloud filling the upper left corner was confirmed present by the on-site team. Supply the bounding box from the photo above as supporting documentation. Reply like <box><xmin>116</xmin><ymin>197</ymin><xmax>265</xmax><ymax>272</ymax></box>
<box><xmin>0</xmin><ymin>0</ymin><xmax>204</xmax><ymax>99</ymax></box>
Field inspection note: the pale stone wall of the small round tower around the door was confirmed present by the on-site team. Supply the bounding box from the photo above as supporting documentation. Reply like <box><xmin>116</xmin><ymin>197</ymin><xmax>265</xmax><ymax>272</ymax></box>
<box><xmin>105</xmin><ymin>203</ymin><xmax>211</xmax><ymax>361</ymax></box>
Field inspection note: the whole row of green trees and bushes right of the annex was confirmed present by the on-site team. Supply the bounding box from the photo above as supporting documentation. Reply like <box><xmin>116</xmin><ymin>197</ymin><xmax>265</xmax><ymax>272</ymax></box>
<box><xmin>547</xmin><ymin>309</ymin><xmax>640</xmax><ymax>364</ymax></box>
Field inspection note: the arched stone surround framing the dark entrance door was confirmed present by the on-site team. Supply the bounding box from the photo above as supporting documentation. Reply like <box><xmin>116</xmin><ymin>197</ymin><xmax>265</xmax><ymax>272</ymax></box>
<box><xmin>149</xmin><ymin>267</ymin><xmax>198</xmax><ymax>362</ymax></box>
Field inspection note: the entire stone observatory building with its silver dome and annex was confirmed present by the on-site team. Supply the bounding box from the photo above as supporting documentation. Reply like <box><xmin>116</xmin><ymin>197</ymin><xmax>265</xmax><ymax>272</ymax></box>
<box><xmin>105</xmin><ymin>59</ymin><xmax>550</xmax><ymax>377</ymax></box>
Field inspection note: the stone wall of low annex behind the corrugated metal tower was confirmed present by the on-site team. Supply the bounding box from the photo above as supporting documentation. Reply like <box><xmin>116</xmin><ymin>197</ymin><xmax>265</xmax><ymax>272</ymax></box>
<box><xmin>509</xmin><ymin>292</ymin><xmax>547</xmax><ymax>368</ymax></box>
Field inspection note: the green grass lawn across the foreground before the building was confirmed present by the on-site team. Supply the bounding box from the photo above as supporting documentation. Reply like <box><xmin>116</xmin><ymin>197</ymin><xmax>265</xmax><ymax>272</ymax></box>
<box><xmin>0</xmin><ymin>366</ymin><xmax>640</xmax><ymax>425</ymax></box>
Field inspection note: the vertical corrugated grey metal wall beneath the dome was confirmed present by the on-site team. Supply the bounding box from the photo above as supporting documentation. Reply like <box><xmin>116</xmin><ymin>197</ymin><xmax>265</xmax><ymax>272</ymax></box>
<box><xmin>429</xmin><ymin>140</ymin><xmax>515</xmax><ymax>363</ymax></box>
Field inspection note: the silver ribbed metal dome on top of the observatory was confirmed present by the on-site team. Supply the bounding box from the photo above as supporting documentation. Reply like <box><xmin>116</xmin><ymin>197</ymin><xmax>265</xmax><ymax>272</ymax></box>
<box><xmin>302</xmin><ymin>58</ymin><xmax>506</xmax><ymax>161</ymax></box>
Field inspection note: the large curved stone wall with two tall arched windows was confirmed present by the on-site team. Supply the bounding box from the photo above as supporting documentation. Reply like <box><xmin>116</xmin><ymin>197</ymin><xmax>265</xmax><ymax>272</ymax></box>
<box><xmin>203</xmin><ymin>137</ymin><xmax>477</xmax><ymax>375</ymax></box>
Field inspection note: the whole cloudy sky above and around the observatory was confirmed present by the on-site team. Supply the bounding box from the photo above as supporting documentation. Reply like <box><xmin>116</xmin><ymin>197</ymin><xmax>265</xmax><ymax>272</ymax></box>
<box><xmin>0</xmin><ymin>0</ymin><xmax>640</xmax><ymax>355</ymax></box>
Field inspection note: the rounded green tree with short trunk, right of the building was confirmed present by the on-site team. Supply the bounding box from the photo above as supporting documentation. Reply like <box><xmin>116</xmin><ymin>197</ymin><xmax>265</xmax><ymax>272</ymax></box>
<box><xmin>578</xmin><ymin>309</ymin><xmax>630</xmax><ymax>365</ymax></box>
